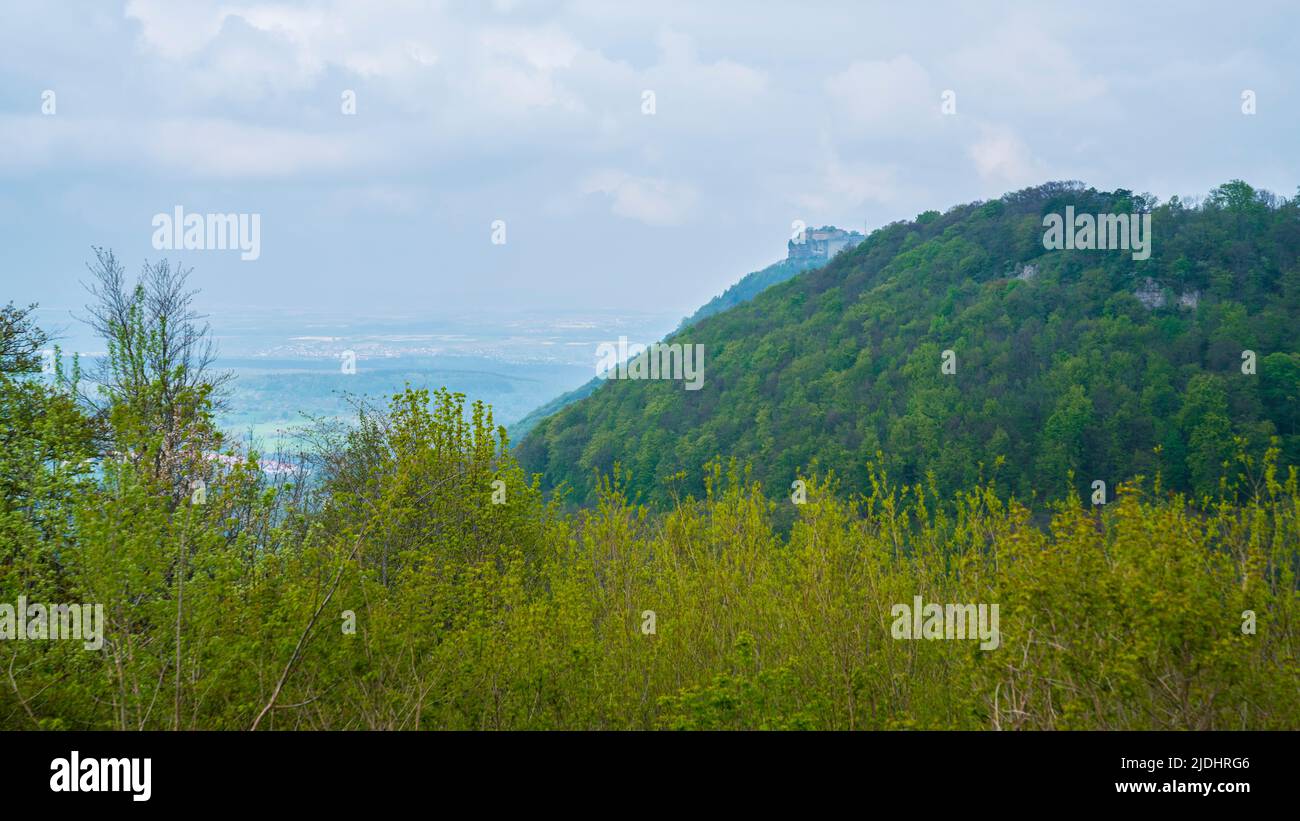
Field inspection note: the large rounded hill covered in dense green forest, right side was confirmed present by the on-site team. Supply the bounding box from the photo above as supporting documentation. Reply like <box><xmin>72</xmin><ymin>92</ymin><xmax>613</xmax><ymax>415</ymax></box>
<box><xmin>519</xmin><ymin>181</ymin><xmax>1300</xmax><ymax>501</ymax></box>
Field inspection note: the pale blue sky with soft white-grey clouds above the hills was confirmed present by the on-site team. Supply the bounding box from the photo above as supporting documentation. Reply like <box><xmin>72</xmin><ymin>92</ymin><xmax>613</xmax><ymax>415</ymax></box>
<box><xmin>0</xmin><ymin>0</ymin><xmax>1300</xmax><ymax>316</ymax></box>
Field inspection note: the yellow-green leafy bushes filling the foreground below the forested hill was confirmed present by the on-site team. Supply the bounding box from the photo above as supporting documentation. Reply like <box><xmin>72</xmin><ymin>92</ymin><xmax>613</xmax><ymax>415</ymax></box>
<box><xmin>0</xmin><ymin>379</ymin><xmax>1300</xmax><ymax>729</ymax></box>
